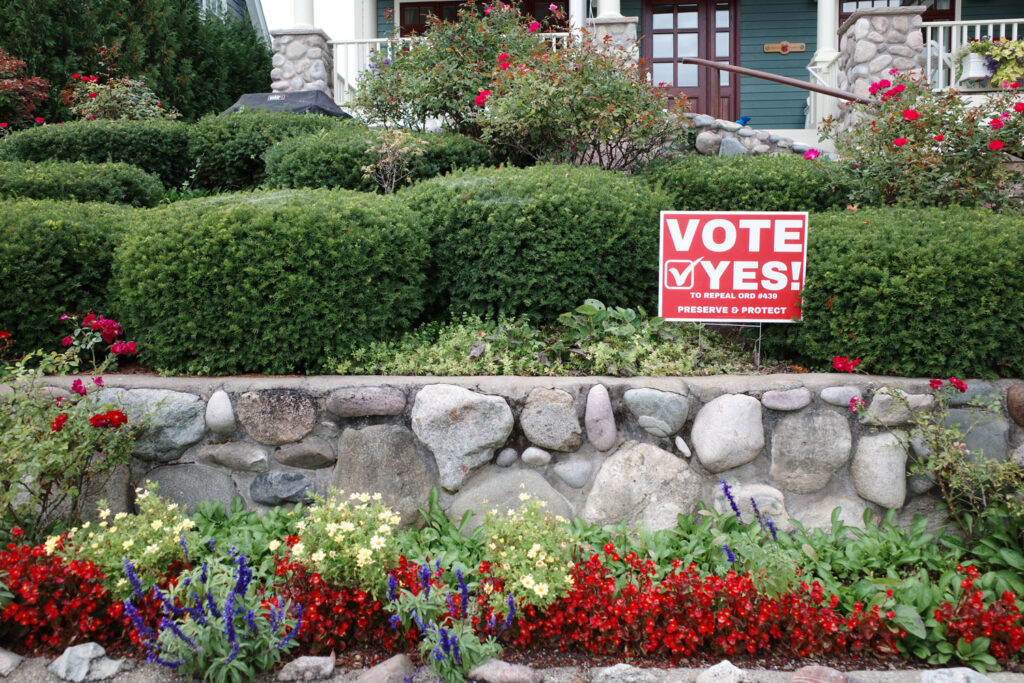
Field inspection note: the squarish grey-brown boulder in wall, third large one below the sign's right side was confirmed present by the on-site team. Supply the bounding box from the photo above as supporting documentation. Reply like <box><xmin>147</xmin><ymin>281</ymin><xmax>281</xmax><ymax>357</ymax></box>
<box><xmin>771</xmin><ymin>411</ymin><xmax>853</xmax><ymax>494</ymax></box>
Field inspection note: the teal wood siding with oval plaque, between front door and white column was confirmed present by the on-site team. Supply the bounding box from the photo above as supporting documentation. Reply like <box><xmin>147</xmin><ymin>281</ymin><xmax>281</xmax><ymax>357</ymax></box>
<box><xmin>739</xmin><ymin>0</ymin><xmax>824</xmax><ymax>128</ymax></box>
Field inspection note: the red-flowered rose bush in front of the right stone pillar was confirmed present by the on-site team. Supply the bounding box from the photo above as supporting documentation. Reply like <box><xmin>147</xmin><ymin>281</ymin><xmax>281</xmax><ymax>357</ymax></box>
<box><xmin>822</xmin><ymin>73</ymin><xmax>1024</xmax><ymax>207</ymax></box>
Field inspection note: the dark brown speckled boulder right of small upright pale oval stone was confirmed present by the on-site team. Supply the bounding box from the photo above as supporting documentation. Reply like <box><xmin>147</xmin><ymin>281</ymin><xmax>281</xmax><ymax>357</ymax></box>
<box><xmin>234</xmin><ymin>389</ymin><xmax>316</xmax><ymax>445</ymax></box>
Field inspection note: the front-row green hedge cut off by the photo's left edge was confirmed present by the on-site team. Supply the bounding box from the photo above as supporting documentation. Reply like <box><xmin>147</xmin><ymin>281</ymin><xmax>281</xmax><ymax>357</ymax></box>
<box><xmin>0</xmin><ymin>200</ymin><xmax>132</xmax><ymax>352</ymax></box>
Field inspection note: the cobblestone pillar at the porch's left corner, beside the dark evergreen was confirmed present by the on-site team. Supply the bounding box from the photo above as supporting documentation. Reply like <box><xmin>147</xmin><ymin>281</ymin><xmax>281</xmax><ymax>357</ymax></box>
<box><xmin>270</xmin><ymin>27</ymin><xmax>334</xmax><ymax>99</ymax></box>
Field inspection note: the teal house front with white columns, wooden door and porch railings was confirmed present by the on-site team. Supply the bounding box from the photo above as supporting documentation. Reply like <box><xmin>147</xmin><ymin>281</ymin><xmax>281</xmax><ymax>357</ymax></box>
<box><xmin>276</xmin><ymin>0</ymin><xmax>1024</xmax><ymax>129</ymax></box>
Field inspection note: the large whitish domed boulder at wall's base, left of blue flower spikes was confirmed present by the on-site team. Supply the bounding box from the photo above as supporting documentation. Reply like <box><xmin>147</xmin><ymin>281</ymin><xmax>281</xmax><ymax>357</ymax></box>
<box><xmin>583</xmin><ymin>441</ymin><xmax>700</xmax><ymax>530</ymax></box>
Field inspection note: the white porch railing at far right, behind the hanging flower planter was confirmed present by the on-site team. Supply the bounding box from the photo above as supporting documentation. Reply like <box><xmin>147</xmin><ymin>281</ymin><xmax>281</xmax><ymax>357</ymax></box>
<box><xmin>921</xmin><ymin>18</ymin><xmax>1024</xmax><ymax>92</ymax></box>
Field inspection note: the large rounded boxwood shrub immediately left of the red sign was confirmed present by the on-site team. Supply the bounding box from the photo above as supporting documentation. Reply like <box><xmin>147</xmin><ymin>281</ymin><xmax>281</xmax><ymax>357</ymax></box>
<box><xmin>399</xmin><ymin>165</ymin><xmax>669</xmax><ymax>321</ymax></box>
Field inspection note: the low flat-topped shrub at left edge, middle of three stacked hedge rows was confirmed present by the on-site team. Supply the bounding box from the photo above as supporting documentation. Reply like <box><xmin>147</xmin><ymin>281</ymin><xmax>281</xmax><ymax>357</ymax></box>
<box><xmin>0</xmin><ymin>161</ymin><xmax>164</xmax><ymax>207</ymax></box>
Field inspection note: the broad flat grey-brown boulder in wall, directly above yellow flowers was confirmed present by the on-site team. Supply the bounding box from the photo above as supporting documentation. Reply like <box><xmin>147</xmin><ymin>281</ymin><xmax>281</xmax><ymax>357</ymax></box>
<box><xmin>331</xmin><ymin>425</ymin><xmax>437</xmax><ymax>526</ymax></box>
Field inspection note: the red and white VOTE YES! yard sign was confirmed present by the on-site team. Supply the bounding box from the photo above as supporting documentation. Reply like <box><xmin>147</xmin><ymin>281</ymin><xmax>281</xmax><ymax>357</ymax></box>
<box><xmin>657</xmin><ymin>211</ymin><xmax>807</xmax><ymax>323</ymax></box>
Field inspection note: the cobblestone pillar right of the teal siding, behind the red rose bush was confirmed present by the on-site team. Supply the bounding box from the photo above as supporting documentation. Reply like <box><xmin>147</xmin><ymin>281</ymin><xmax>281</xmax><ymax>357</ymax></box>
<box><xmin>839</xmin><ymin>5</ymin><xmax>925</xmax><ymax>97</ymax></box>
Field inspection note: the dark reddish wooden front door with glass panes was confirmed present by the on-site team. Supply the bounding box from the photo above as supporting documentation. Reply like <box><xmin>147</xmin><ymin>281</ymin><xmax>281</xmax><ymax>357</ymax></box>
<box><xmin>642</xmin><ymin>0</ymin><xmax>739</xmax><ymax>121</ymax></box>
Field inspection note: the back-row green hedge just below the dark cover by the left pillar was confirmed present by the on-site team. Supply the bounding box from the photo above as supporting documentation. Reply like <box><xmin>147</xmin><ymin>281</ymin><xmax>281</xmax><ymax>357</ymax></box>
<box><xmin>189</xmin><ymin>112</ymin><xmax>365</xmax><ymax>189</ymax></box>
